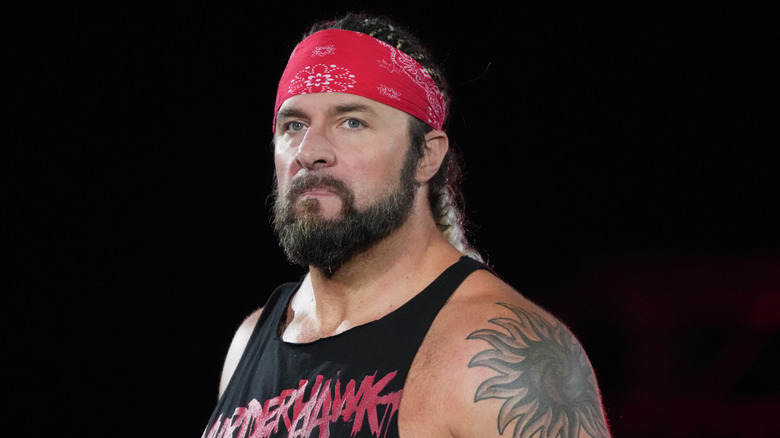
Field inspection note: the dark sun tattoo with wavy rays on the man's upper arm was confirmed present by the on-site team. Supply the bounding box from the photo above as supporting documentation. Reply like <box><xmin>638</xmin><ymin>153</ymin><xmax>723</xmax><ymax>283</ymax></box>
<box><xmin>467</xmin><ymin>303</ymin><xmax>609</xmax><ymax>438</ymax></box>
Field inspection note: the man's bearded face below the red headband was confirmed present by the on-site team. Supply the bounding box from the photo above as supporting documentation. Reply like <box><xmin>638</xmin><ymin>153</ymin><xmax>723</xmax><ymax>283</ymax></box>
<box><xmin>274</xmin><ymin>93</ymin><xmax>418</xmax><ymax>274</ymax></box>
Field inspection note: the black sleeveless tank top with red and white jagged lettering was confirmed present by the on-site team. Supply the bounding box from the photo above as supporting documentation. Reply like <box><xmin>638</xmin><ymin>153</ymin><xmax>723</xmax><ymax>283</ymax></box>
<box><xmin>203</xmin><ymin>257</ymin><xmax>484</xmax><ymax>438</ymax></box>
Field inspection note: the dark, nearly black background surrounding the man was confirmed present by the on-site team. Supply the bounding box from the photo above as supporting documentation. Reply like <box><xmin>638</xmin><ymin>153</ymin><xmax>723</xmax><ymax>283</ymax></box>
<box><xmin>7</xmin><ymin>1</ymin><xmax>780</xmax><ymax>437</ymax></box>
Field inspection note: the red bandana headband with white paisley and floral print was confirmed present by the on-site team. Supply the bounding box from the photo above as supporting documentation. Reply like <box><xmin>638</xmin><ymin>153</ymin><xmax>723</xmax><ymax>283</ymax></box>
<box><xmin>273</xmin><ymin>29</ymin><xmax>444</xmax><ymax>130</ymax></box>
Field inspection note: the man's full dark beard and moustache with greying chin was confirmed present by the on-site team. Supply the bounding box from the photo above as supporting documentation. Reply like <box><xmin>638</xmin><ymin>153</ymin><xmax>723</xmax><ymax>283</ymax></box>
<box><xmin>273</xmin><ymin>152</ymin><xmax>419</xmax><ymax>275</ymax></box>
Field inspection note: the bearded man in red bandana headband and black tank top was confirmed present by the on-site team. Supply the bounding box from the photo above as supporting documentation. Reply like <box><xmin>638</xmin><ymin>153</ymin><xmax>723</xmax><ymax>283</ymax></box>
<box><xmin>203</xmin><ymin>15</ymin><xmax>609</xmax><ymax>438</ymax></box>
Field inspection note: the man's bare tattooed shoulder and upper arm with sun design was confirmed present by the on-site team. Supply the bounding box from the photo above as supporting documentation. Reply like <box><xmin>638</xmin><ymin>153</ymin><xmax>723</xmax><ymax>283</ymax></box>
<box><xmin>405</xmin><ymin>270</ymin><xmax>609</xmax><ymax>438</ymax></box>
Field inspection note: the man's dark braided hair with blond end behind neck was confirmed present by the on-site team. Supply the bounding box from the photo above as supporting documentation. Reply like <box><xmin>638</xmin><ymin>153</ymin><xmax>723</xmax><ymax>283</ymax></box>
<box><xmin>304</xmin><ymin>13</ymin><xmax>483</xmax><ymax>261</ymax></box>
